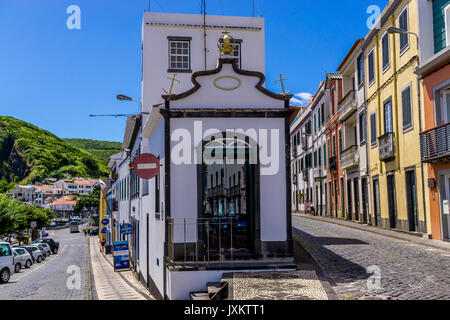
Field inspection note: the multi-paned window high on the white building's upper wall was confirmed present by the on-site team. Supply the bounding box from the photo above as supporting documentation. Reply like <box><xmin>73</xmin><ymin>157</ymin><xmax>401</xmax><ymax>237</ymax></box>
<box><xmin>168</xmin><ymin>37</ymin><xmax>191</xmax><ymax>71</ymax></box>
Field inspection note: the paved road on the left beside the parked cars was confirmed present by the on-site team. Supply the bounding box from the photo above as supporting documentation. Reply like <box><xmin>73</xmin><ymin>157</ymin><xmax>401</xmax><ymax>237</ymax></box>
<box><xmin>0</xmin><ymin>229</ymin><xmax>90</xmax><ymax>300</ymax></box>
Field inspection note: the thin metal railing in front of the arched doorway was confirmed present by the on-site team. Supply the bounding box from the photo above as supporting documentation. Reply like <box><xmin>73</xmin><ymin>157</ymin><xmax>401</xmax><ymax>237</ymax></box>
<box><xmin>166</xmin><ymin>217</ymin><xmax>248</xmax><ymax>266</ymax></box>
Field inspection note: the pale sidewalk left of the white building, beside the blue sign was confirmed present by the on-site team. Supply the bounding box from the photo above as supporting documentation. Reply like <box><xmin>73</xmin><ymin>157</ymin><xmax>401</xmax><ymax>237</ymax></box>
<box><xmin>89</xmin><ymin>237</ymin><xmax>154</xmax><ymax>300</ymax></box>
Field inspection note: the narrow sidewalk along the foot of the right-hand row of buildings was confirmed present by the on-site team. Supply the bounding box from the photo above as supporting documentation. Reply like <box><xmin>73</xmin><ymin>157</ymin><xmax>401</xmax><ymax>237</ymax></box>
<box><xmin>292</xmin><ymin>213</ymin><xmax>450</xmax><ymax>251</ymax></box>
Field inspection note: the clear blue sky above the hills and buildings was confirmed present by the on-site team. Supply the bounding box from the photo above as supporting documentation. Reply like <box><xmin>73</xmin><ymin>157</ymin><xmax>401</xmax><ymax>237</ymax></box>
<box><xmin>0</xmin><ymin>0</ymin><xmax>388</xmax><ymax>141</ymax></box>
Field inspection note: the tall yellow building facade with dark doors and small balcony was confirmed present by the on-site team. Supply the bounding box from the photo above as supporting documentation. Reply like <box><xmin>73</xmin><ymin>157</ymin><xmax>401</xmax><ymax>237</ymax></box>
<box><xmin>363</xmin><ymin>0</ymin><xmax>430</xmax><ymax>233</ymax></box>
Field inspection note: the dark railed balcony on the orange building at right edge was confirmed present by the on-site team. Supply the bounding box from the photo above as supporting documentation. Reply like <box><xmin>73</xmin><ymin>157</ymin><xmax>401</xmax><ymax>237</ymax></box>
<box><xmin>420</xmin><ymin>122</ymin><xmax>450</xmax><ymax>164</ymax></box>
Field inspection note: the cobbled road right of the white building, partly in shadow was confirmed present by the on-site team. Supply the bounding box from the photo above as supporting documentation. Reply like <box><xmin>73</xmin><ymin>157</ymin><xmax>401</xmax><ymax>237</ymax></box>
<box><xmin>292</xmin><ymin>216</ymin><xmax>450</xmax><ymax>300</ymax></box>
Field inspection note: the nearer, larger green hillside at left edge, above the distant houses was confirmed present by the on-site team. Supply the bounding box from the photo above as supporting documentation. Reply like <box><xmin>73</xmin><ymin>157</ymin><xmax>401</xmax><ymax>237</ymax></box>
<box><xmin>0</xmin><ymin>116</ymin><xmax>108</xmax><ymax>193</ymax></box>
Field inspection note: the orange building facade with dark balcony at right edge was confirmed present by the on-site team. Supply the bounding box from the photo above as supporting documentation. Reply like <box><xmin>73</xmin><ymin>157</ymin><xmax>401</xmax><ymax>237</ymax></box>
<box><xmin>419</xmin><ymin>61</ymin><xmax>450</xmax><ymax>240</ymax></box>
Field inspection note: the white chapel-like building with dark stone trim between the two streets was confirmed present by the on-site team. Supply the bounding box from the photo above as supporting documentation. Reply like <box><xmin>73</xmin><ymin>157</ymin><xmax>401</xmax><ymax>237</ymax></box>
<box><xmin>134</xmin><ymin>13</ymin><xmax>295</xmax><ymax>299</ymax></box>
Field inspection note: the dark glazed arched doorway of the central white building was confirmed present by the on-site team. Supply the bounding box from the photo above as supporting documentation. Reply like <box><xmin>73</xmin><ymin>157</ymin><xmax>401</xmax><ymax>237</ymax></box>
<box><xmin>199</xmin><ymin>136</ymin><xmax>259</xmax><ymax>260</ymax></box>
